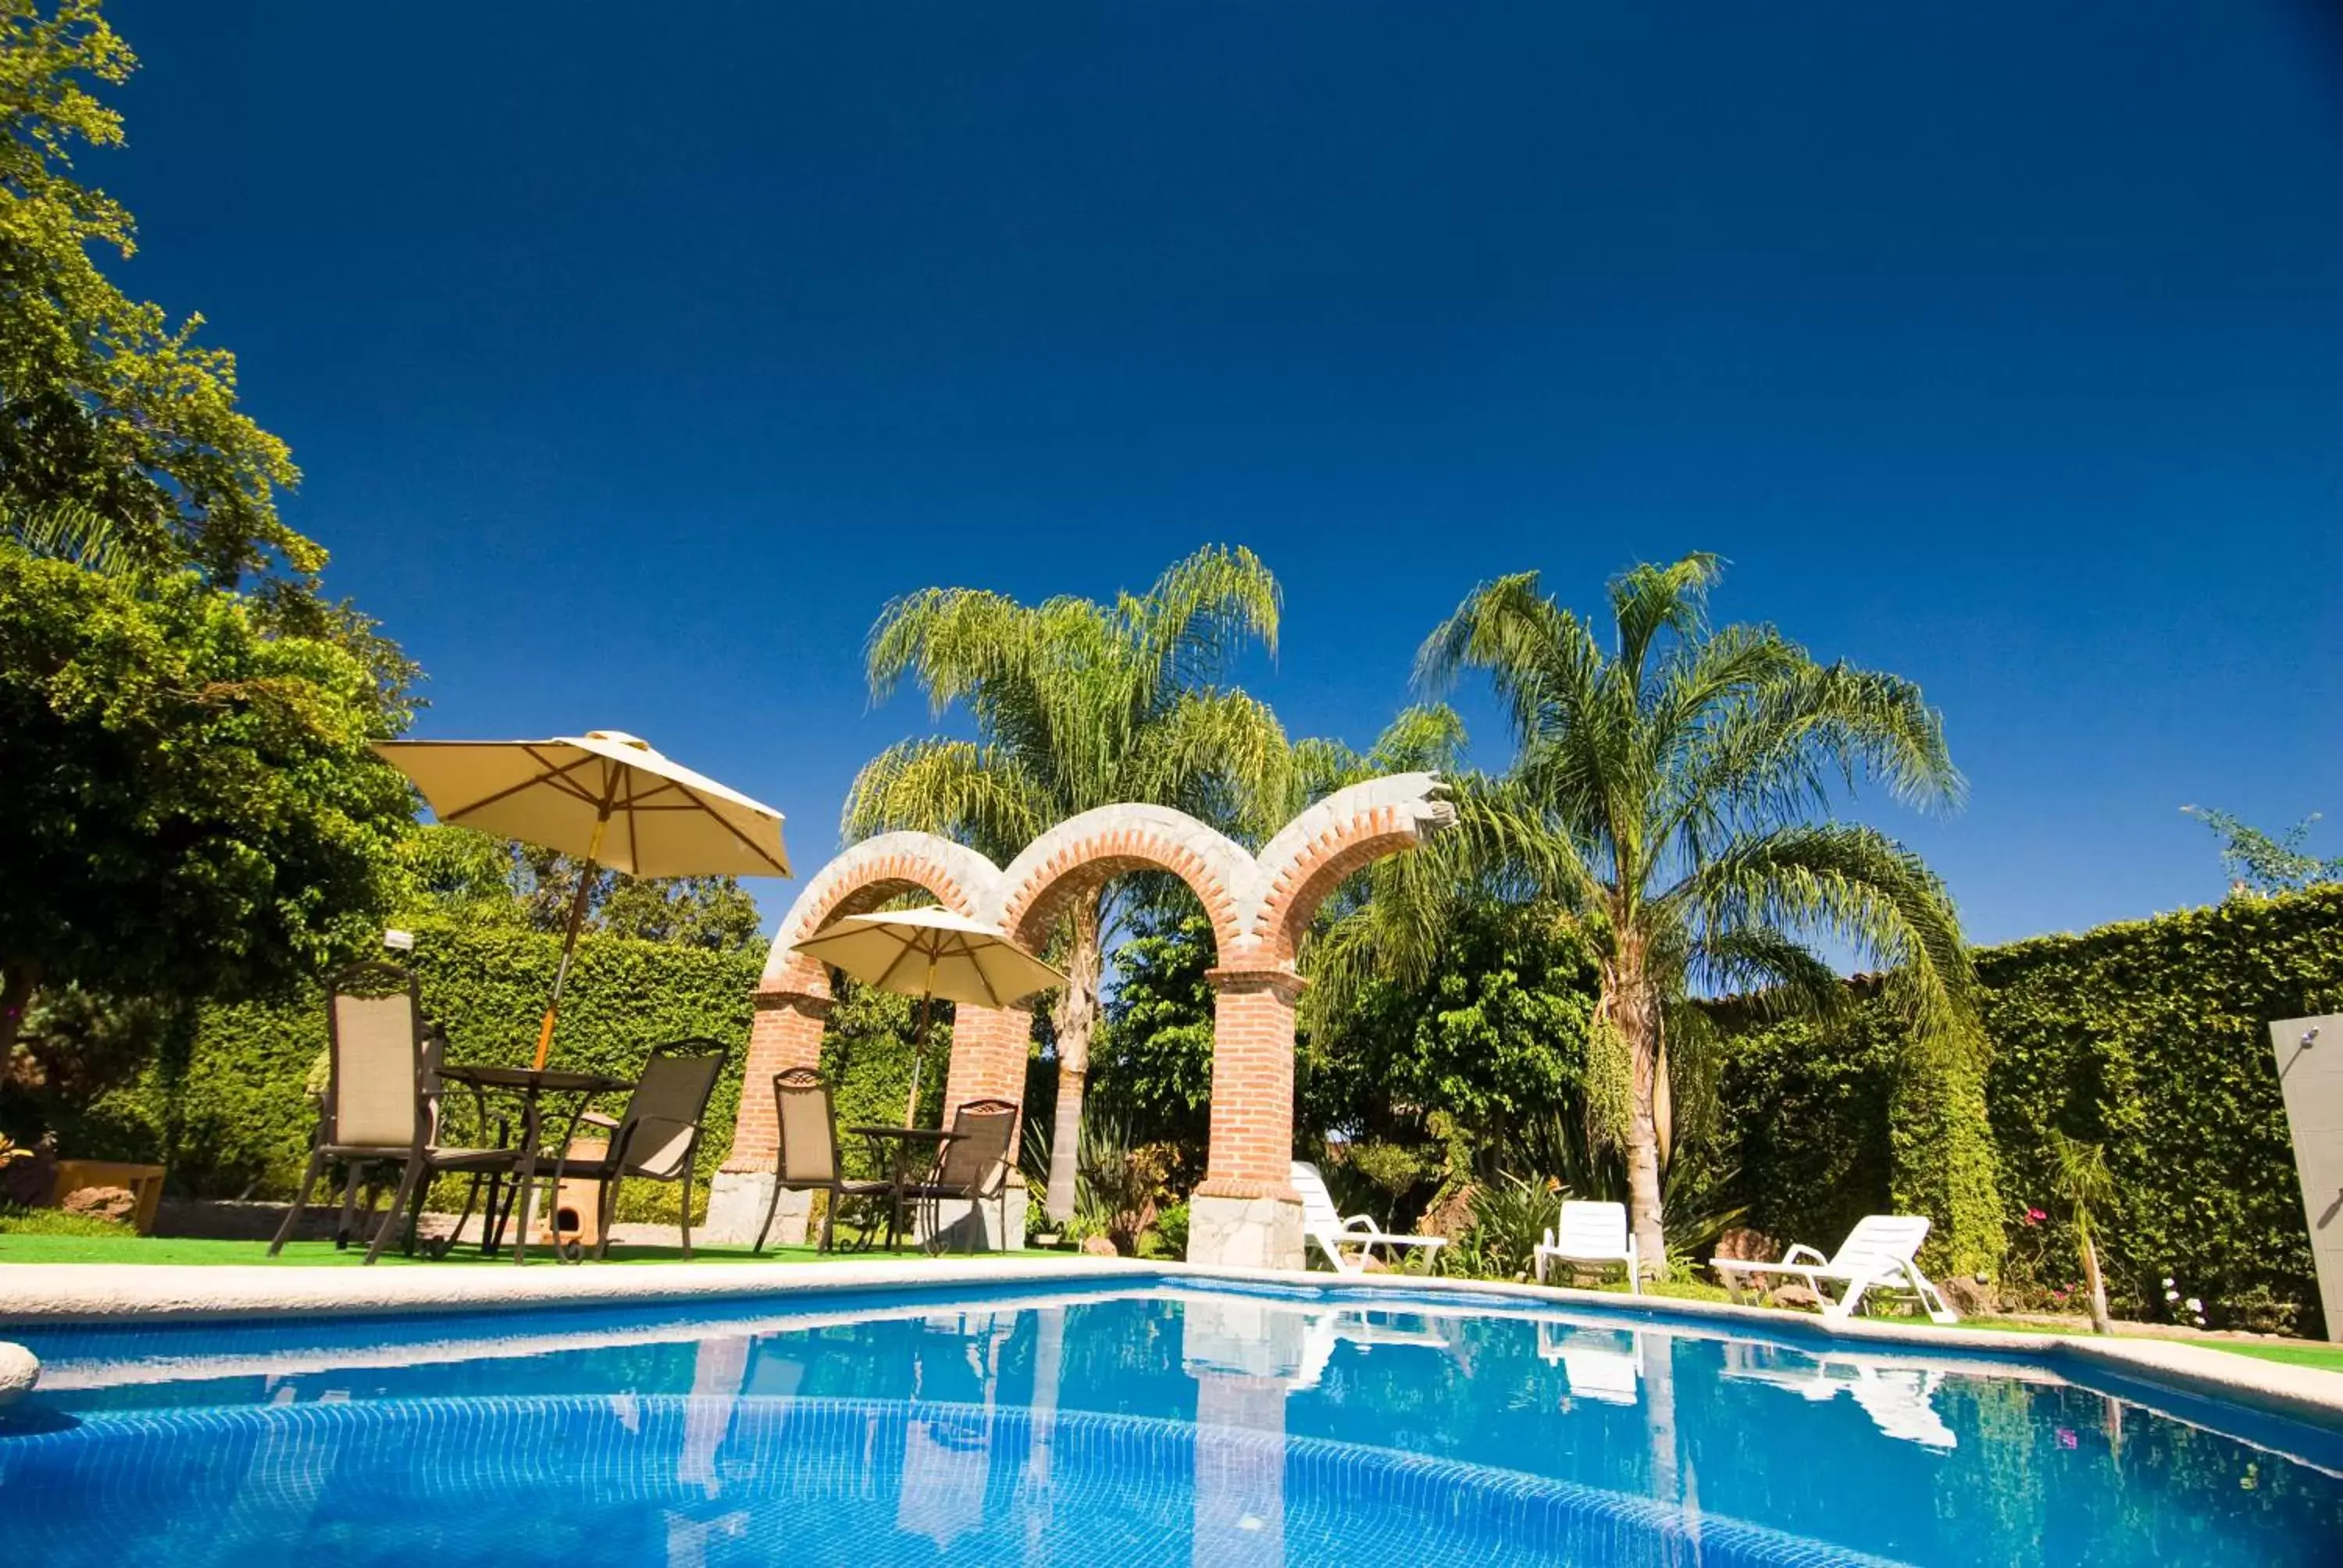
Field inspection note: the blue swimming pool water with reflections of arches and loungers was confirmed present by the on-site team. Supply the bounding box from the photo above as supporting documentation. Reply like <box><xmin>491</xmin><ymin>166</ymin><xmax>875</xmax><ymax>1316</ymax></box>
<box><xmin>0</xmin><ymin>1285</ymin><xmax>2343</xmax><ymax>1568</ymax></box>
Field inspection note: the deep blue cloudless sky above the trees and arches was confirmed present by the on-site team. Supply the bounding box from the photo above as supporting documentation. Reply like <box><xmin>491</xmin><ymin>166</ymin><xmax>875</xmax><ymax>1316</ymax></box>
<box><xmin>101</xmin><ymin>0</ymin><xmax>2343</xmax><ymax>940</ymax></box>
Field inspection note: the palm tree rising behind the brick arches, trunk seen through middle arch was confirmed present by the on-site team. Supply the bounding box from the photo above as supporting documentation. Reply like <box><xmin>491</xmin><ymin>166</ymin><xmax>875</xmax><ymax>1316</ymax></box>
<box><xmin>846</xmin><ymin>546</ymin><xmax>1293</xmax><ymax>1219</ymax></box>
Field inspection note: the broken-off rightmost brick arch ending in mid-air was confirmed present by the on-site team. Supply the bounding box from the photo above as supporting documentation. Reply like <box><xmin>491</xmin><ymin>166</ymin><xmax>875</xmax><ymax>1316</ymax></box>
<box><xmin>1246</xmin><ymin>773</ymin><xmax>1455</xmax><ymax>966</ymax></box>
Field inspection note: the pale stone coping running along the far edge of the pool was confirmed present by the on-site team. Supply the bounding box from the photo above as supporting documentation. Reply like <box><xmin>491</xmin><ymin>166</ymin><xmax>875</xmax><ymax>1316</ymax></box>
<box><xmin>0</xmin><ymin>1256</ymin><xmax>2343</xmax><ymax>1430</ymax></box>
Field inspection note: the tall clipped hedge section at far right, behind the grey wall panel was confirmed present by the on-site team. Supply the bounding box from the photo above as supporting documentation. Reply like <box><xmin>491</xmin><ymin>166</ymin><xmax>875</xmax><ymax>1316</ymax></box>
<box><xmin>1977</xmin><ymin>889</ymin><xmax>2343</xmax><ymax>1334</ymax></box>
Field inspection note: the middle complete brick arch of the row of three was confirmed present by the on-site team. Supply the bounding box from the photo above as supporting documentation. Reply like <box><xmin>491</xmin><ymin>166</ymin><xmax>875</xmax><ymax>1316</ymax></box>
<box><xmin>993</xmin><ymin>807</ymin><xmax>1254</xmax><ymax>964</ymax></box>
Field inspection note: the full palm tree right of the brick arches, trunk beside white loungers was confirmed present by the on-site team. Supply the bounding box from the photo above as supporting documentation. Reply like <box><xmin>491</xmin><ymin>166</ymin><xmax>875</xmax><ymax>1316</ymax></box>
<box><xmin>1418</xmin><ymin>555</ymin><xmax>1970</xmax><ymax>1270</ymax></box>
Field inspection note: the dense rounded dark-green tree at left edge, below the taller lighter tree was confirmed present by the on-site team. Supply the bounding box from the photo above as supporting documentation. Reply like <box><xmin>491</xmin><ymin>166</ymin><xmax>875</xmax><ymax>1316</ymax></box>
<box><xmin>0</xmin><ymin>543</ymin><xmax>412</xmax><ymax>1046</ymax></box>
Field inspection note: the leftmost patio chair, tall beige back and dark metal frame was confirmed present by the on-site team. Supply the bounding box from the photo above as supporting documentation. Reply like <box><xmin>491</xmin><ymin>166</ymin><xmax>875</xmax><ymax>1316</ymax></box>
<box><xmin>269</xmin><ymin>964</ymin><xmax>520</xmax><ymax>1263</ymax></box>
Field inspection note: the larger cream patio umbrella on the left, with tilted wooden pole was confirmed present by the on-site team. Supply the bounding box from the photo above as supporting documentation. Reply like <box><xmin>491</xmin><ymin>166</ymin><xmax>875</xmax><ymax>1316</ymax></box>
<box><xmin>375</xmin><ymin>729</ymin><xmax>790</xmax><ymax>1067</ymax></box>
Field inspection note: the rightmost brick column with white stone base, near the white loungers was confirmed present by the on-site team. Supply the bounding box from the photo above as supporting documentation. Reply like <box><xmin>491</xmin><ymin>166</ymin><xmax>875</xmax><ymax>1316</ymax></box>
<box><xmin>1188</xmin><ymin>966</ymin><xmax>1305</xmax><ymax>1268</ymax></box>
